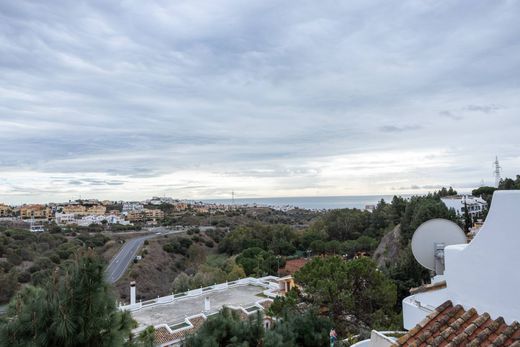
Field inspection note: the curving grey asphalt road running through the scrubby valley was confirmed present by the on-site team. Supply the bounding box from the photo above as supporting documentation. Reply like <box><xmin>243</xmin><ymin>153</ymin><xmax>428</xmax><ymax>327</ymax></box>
<box><xmin>106</xmin><ymin>228</ymin><xmax>186</xmax><ymax>283</ymax></box>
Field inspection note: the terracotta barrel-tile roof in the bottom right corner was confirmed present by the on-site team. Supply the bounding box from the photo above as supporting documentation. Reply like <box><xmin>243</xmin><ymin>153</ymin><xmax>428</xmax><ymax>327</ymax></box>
<box><xmin>394</xmin><ymin>301</ymin><xmax>520</xmax><ymax>347</ymax></box>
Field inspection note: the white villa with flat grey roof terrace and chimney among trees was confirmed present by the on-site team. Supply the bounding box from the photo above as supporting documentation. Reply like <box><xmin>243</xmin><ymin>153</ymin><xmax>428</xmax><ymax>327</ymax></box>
<box><xmin>119</xmin><ymin>276</ymin><xmax>294</xmax><ymax>347</ymax></box>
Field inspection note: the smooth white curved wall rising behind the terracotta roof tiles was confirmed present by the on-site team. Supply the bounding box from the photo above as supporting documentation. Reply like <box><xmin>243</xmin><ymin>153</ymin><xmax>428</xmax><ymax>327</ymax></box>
<box><xmin>445</xmin><ymin>191</ymin><xmax>520</xmax><ymax>323</ymax></box>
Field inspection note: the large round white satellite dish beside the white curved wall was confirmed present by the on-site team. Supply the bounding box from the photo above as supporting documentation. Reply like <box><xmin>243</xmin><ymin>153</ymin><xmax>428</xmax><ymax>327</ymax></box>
<box><xmin>412</xmin><ymin>218</ymin><xmax>467</xmax><ymax>275</ymax></box>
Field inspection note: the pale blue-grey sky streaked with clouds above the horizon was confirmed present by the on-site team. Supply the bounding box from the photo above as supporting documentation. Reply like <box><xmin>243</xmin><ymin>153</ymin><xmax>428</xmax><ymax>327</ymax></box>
<box><xmin>0</xmin><ymin>0</ymin><xmax>520</xmax><ymax>204</ymax></box>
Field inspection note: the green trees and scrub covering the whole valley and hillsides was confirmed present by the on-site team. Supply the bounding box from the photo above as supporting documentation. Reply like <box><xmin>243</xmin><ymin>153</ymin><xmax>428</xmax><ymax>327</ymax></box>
<box><xmin>0</xmin><ymin>185</ymin><xmax>504</xmax><ymax>346</ymax></box>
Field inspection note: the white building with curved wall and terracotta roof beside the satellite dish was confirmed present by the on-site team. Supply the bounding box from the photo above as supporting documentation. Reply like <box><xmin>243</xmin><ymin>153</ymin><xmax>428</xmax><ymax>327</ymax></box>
<box><xmin>353</xmin><ymin>191</ymin><xmax>520</xmax><ymax>347</ymax></box>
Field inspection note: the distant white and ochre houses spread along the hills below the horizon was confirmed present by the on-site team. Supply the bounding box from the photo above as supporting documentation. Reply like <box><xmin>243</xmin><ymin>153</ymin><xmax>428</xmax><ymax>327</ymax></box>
<box><xmin>0</xmin><ymin>194</ymin><xmax>488</xmax><ymax>232</ymax></box>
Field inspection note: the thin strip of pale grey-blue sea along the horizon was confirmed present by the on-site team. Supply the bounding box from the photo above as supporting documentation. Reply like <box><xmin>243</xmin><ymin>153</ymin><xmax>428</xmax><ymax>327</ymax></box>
<box><xmin>203</xmin><ymin>195</ymin><xmax>409</xmax><ymax>210</ymax></box>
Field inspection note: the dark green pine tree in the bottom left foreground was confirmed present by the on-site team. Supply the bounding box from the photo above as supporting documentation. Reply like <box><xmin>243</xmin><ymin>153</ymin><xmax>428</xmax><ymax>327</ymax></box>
<box><xmin>0</xmin><ymin>251</ymin><xmax>134</xmax><ymax>346</ymax></box>
